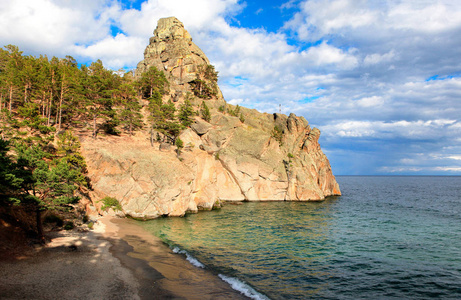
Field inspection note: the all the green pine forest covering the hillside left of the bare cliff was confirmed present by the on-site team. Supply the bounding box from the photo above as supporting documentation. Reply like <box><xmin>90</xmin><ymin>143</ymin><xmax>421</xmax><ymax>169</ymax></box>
<box><xmin>0</xmin><ymin>45</ymin><xmax>218</xmax><ymax>240</ymax></box>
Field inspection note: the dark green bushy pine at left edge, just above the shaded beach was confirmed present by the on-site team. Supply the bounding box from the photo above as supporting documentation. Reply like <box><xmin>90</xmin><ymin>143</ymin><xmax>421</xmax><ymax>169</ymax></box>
<box><xmin>0</xmin><ymin>134</ymin><xmax>86</xmax><ymax>238</ymax></box>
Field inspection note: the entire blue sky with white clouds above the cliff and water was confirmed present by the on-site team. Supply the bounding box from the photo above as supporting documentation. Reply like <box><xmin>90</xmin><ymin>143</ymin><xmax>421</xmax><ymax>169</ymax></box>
<box><xmin>0</xmin><ymin>0</ymin><xmax>461</xmax><ymax>175</ymax></box>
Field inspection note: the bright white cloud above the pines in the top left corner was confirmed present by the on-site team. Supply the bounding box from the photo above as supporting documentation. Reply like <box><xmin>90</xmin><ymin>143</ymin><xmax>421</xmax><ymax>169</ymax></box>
<box><xmin>0</xmin><ymin>0</ymin><xmax>113</xmax><ymax>55</ymax></box>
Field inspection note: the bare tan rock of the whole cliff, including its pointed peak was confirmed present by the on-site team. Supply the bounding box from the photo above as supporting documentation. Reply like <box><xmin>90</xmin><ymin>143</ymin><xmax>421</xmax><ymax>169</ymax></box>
<box><xmin>82</xmin><ymin>18</ymin><xmax>341</xmax><ymax>218</ymax></box>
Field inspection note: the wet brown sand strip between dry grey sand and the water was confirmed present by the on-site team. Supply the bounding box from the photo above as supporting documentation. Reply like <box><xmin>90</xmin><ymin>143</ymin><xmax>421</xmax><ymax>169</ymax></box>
<box><xmin>102</xmin><ymin>218</ymin><xmax>248</xmax><ymax>299</ymax></box>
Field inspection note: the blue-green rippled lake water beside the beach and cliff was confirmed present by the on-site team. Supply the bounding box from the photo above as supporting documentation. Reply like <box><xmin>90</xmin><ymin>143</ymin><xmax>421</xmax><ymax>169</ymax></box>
<box><xmin>139</xmin><ymin>176</ymin><xmax>461</xmax><ymax>299</ymax></box>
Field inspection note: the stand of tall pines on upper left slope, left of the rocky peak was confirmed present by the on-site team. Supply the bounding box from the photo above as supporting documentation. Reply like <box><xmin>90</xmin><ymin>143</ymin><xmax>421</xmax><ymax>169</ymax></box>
<box><xmin>0</xmin><ymin>45</ymin><xmax>144</xmax><ymax>137</ymax></box>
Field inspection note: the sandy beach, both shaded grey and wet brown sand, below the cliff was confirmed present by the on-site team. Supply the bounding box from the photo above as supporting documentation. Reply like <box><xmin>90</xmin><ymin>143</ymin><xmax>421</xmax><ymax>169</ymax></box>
<box><xmin>0</xmin><ymin>216</ymin><xmax>246</xmax><ymax>299</ymax></box>
